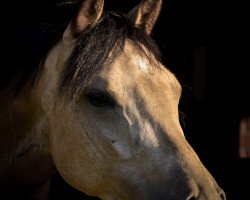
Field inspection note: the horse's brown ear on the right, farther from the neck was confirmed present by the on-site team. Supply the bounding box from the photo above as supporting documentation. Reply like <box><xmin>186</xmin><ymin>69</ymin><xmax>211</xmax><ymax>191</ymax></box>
<box><xmin>127</xmin><ymin>0</ymin><xmax>162</xmax><ymax>34</ymax></box>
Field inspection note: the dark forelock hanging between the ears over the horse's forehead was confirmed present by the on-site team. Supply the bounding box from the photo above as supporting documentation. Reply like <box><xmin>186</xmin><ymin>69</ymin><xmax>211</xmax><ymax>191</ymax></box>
<box><xmin>58</xmin><ymin>12</ymin><xmax>160</xmax><ymax>100</ymax></box>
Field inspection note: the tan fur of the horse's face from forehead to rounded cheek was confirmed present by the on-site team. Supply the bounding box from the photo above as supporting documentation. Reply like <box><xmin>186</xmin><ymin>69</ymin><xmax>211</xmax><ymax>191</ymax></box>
<box><xmin>39</xmin><ymin>39</ymin><xmax>225</xmax><ymax>199</ymax></box>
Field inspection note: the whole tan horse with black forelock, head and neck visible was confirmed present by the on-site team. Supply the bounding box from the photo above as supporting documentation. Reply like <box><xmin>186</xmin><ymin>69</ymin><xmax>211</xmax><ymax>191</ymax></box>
<box><xmin>0</xmin><ymin>0</ymin><xmax>226</xmax><ymax>200</ymax></box>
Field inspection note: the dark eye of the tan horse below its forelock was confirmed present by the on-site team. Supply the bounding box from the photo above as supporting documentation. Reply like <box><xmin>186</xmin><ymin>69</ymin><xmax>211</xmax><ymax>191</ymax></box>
<box><xmin>87</xmin><ymin>90</ymin><xmax>115</xmax><ymax>108</ymax></box>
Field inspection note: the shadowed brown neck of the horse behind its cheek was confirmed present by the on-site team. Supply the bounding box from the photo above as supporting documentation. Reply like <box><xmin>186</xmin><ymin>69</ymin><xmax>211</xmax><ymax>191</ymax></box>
<box><xmin>0</xmin><ymin>41</ymin><xmax>67</xmax><ymax>166</ymax></box>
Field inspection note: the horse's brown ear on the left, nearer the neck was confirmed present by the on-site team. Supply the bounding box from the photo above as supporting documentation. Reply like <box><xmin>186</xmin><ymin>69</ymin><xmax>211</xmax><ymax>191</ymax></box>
<box><xmin>63</xmin><ymin>0</ymin><xmax>104</xmax><ymax>38</ymax></box>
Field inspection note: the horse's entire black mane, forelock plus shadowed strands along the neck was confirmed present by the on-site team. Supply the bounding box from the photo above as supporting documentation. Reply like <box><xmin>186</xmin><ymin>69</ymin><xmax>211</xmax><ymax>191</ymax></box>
<box><xmin>0</xmin><ymin>12</ymin><xmax>161</xmax><ymax>100</ymax></box>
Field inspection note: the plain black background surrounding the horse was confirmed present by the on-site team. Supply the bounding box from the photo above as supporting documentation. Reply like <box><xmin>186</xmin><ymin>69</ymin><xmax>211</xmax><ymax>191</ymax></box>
<box><xmin>1</xmin><ymin>0</ymin><xmax>250</xmax><ymax>200</ymax></box>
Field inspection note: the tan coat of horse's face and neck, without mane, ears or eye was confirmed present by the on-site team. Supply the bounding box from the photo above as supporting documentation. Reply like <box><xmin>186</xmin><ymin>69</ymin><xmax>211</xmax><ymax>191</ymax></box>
<box><xmin>0</xmin><ymin>1</ymin><xmax>225</xmax><ymax>200</ymax></box>
